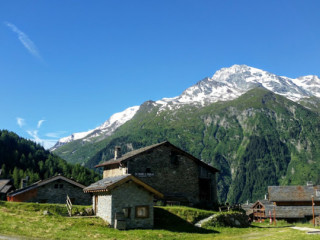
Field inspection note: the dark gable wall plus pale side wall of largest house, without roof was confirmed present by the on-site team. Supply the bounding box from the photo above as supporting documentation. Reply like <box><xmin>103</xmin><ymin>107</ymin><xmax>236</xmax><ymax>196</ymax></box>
<box><xmin>103</xmin><ymin>145</ymin><xmax>217</xmax><ymax>205</ymax></box>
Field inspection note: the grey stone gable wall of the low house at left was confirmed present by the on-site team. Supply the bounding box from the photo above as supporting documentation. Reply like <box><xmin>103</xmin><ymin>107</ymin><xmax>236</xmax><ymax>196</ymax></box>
<box><xmin>25</xmin><ymin>179</ymin><xmax>92</xmax><ymax>205</ymax></box>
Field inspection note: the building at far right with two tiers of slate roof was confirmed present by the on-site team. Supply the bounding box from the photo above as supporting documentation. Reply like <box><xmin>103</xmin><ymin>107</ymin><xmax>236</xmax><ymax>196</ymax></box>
<box><xmin>268</xmin><ymin>185</ymin><xmax>320</xmax><ymax>220</ymax></box>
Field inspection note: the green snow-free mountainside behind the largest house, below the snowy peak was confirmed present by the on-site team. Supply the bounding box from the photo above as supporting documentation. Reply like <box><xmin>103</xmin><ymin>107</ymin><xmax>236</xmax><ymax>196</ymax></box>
<box><xmin>87</xmin><ymin>88</ymin><xmax>320</xmax><ymax>203</ymax></box>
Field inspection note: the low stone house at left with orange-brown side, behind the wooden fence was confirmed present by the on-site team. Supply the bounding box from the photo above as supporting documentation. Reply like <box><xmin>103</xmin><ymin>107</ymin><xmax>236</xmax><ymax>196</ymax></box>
<box><xmin>7</xmin><ymin>175</ymin><xmax>92</xmax><ymax>205</ymax></box>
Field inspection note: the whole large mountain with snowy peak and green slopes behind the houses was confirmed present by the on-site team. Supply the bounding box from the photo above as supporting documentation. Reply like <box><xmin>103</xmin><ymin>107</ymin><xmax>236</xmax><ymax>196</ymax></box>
<box><xmin>50</xmin><ymin>65</ymin><xmax>320</xmax><ymax>203</ymax></box>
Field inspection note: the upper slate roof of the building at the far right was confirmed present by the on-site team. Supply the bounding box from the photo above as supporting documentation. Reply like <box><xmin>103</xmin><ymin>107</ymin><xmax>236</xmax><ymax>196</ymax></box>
<box><xmin>268</xmin><ymin>185</ymin><xmax>320</xmax><ymax>202</ymax></box>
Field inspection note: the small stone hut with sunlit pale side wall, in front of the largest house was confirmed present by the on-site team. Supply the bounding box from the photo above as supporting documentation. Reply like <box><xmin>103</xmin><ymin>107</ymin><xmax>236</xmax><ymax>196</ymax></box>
<box><xmin>84</xmin><ymin>174</ymin><xmax>163</xmax><ymax>229</ymax></box>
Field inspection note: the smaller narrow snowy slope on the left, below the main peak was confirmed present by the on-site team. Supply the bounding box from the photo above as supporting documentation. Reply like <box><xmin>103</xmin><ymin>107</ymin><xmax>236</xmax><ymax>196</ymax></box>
<box><xmin>51</xmin><ymin>106</ymin><xmax>140</xmax><ymax>151</ymax></box>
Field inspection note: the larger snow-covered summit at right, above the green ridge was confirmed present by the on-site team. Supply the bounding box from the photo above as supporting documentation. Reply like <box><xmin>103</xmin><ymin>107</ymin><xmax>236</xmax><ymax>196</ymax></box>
<box><xmin>156</xmin><ymin>65</ymin><xmax>320</xmax><ymax>109</ymax></box>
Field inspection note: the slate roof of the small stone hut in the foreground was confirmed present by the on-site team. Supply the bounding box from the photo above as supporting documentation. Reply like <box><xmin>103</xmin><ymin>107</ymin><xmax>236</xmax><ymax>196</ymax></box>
<box><xmin>83</xmin><ymin>174</ymin><xmax>163</xmax><ymax>198</ymax></box>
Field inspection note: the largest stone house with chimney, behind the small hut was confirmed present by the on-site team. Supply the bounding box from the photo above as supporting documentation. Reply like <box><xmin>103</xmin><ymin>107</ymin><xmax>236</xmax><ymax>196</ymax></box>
<box><xmin>96</xmin><ymin>141</ymin><xmax>219</xmax><ymax>206</ymax></box>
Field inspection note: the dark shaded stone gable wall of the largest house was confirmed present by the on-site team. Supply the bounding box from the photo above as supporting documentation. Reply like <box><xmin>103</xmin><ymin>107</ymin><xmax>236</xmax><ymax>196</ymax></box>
<box><xmin>127</xmin><ymin>146</ymin><xmax>199</xmax><ymax>203</ymax></box>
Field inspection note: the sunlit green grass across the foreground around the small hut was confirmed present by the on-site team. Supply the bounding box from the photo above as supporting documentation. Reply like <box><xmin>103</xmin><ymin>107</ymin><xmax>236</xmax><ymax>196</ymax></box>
<box><xmin>0</xmin><ymin>201</ymin><xmax>320</xmax><ymax>240</ymax></box>
